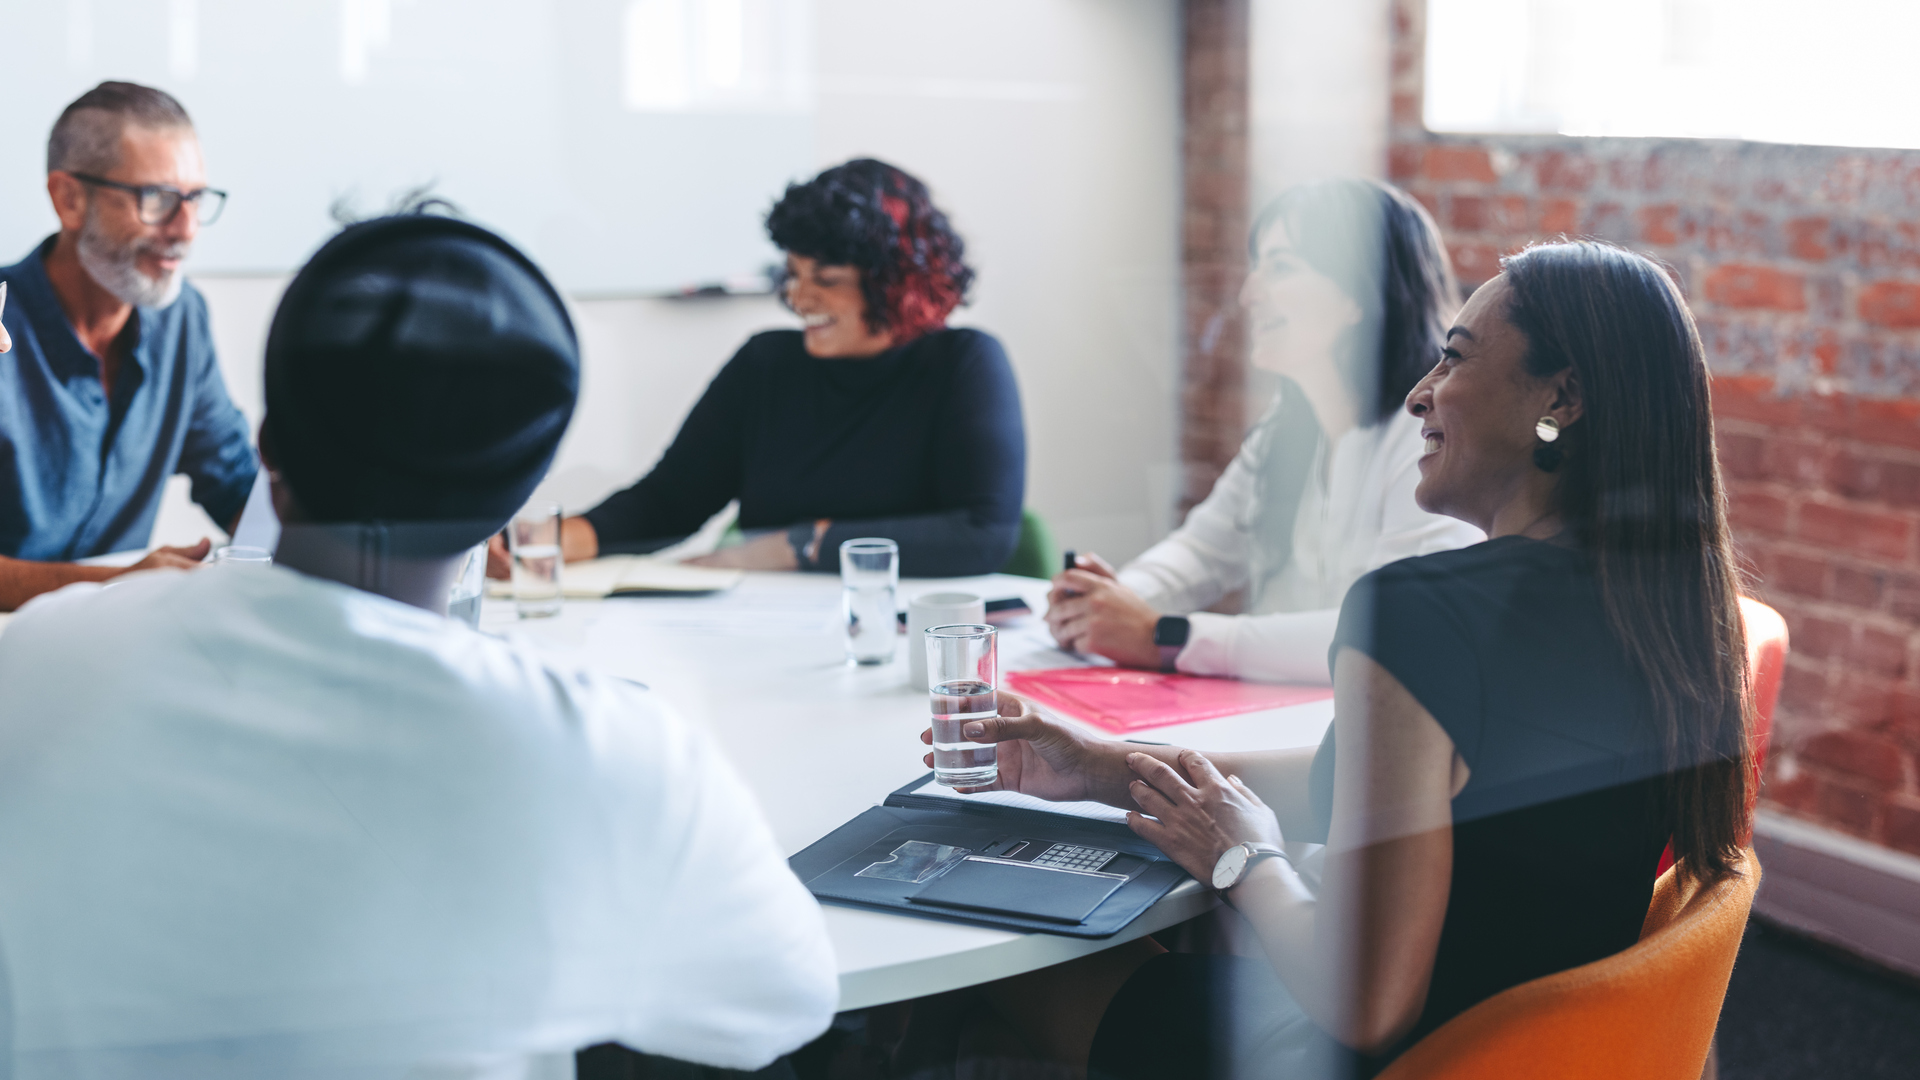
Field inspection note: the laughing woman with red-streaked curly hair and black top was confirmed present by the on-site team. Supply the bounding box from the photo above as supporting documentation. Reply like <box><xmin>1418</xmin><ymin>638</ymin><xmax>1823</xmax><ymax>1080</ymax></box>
<box><xmin>563</xmin><ymin>158</ymin><xmax>1027</xmax><ymax>577</ymax></box>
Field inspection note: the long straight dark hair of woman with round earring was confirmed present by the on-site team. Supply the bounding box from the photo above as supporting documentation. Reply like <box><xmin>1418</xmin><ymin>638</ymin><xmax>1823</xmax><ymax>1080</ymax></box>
<box><xmin>1503</xmin><ymin>240</ymin><xmax>1753</xmax><ymax>880</ymax></box>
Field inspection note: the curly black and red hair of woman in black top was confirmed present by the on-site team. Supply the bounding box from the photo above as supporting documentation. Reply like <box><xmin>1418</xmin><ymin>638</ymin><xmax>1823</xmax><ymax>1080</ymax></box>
<box><xmin>766</xmin><ymin>158</ymin><xmax>973</xmax><ymax>342</ymax></box>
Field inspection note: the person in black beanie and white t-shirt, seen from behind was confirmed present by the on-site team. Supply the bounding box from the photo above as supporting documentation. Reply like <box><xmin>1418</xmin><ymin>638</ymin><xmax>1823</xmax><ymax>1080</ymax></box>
<box><xmin>0</xmin><ymin>213</ymin><xmax>837</xmax><ymax>1080</ymax></box>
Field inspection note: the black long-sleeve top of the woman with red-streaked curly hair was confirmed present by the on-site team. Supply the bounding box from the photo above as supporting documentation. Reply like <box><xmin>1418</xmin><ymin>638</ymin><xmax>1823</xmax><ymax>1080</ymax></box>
<box><xmin>586</xmin><ymin>331</ymin><xmax>1027</xmax><ymax>577</ymax></box>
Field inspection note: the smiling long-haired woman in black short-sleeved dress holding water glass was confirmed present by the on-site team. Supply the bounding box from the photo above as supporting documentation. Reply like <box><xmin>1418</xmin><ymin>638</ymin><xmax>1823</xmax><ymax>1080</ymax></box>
<box><xmin>921</xmin><ymin>242</ymin><xmax>1751</xmax><ymax>1076</ymax></box>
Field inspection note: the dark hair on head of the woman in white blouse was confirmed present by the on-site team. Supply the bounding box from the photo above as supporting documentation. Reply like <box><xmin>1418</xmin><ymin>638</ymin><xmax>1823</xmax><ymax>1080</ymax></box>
<box><xmin>1246</xmin><ymin>181</ymin><xmax>1459</xmax><ymax>425</ymax></box>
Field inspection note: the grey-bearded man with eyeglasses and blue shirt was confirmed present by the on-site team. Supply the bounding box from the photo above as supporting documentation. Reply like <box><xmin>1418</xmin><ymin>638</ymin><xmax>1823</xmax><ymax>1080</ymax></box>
<box><xmin>0</xmin><ymin>83</ymin><xmax>259</xmax><ymax>611</ymax></box>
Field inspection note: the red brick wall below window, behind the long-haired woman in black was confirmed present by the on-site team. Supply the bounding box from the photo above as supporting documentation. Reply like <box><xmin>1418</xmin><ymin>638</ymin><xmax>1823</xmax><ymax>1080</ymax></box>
<box><xmin>1390</xmin><ymin>0</ymin><xmax>1920</xmax><ymax>853</ymax></box>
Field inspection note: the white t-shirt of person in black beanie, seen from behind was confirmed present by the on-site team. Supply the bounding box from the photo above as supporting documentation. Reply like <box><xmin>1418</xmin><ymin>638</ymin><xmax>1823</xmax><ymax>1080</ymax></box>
<box><xmin>0</xmin><ymin>567</ymin><xmax>839</xmax><ymax>1080</ymax></box>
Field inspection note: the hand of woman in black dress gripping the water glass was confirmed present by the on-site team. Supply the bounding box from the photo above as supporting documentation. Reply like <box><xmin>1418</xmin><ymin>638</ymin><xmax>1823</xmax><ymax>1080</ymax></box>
<box><xmin>920</xmin><ymin>690</ymin><xmax>1127</xmax><ymax>805</ymax></box>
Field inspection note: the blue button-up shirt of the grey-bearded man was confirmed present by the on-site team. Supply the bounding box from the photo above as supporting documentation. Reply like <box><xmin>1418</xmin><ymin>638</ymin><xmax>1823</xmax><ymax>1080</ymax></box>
<box><xmin>0</xmin><ymin>238</ymin><xmax>259</xmax><ymax>561</ymax></box>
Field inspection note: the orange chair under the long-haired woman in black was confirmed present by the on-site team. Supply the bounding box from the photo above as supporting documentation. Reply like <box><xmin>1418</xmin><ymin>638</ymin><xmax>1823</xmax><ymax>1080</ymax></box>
<box><xmin>1379</xmin><ymin>849</ymin><xmax>1761</xmax><ymax>1080</ymax></box>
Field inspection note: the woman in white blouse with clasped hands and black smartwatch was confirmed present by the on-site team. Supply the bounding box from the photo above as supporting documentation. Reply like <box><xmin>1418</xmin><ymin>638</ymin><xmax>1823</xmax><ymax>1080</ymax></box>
<box><xmin>1046</xmin><ymin>181</ymin><xmax>1484</xmax><ymax>684</ymax></box>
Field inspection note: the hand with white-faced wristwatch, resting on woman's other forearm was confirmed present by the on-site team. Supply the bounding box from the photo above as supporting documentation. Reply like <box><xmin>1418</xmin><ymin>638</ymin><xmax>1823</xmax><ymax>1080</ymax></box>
<box><xmin>1127</xmin><ymin>749</ymin><xmax>1283</xmax><ymax>882</ymax></box>
